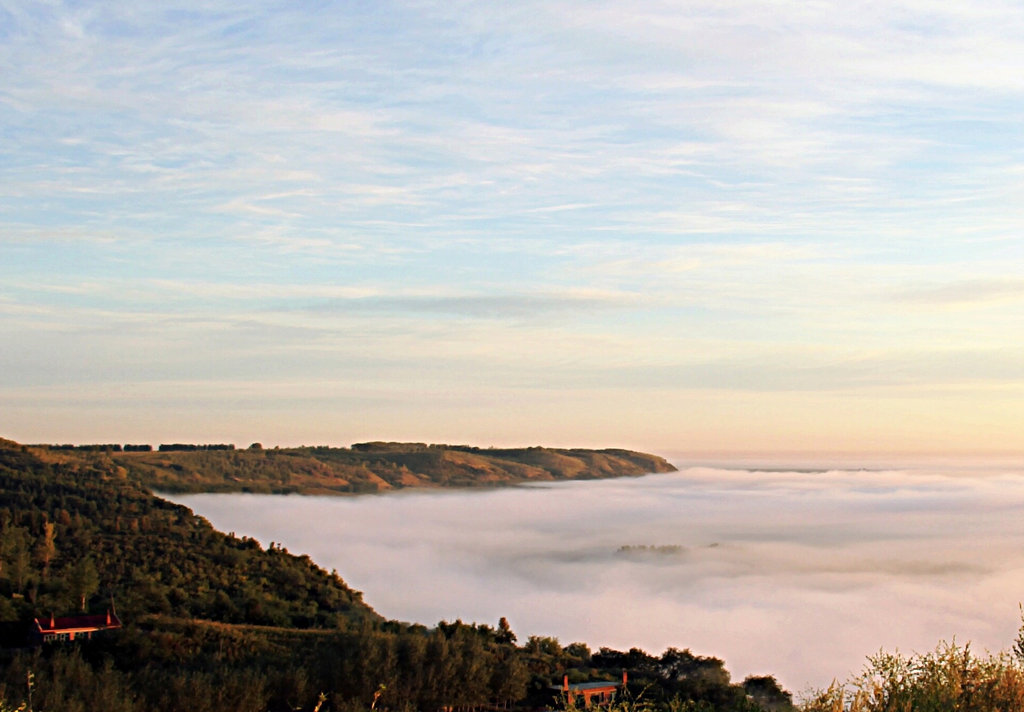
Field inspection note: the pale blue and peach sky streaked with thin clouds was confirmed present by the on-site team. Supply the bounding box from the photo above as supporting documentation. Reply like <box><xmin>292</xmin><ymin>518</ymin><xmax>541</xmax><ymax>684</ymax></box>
<box><xmin>0</xmin><ymin>0</ymin><xmax>1024</xmax><ymax>454</ymax></box>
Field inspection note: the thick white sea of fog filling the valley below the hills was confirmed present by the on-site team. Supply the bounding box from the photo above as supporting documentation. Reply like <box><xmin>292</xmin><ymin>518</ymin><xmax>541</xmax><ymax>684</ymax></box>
<box><xmin>174</xmin><ymin>464</ymin><xmax>1024</xmax><ymax>693</ymax></box>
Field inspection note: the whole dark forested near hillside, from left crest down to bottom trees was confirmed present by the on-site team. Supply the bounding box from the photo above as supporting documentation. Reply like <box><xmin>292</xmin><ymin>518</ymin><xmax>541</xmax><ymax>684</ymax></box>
<box><xmin>0</xmin><ymin>441</ymin><xmax>792</xmax><ymax>712</ymax></box>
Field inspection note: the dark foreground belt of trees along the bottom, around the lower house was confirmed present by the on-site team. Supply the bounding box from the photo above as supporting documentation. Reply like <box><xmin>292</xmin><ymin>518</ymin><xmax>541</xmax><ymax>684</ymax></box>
<box><xmin>0</xmin><ymin>619</ymin><xmax>793</xmax><ymax>712</ymax></box>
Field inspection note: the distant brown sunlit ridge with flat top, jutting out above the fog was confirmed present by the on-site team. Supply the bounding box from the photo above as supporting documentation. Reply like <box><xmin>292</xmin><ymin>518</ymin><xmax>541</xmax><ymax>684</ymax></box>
<box><xmin>32</xmin><ymin>443</ymin><xmax>675</xmax><ymax>494</ymax></box>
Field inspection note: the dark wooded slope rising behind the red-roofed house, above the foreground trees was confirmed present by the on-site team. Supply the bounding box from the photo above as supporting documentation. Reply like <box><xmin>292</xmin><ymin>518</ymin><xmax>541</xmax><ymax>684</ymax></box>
<box><xmin>0</xmin><ymin>441</ymin><xmax>377</xmax><ymax>628</ymax></box>
